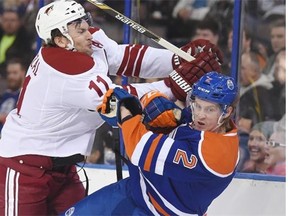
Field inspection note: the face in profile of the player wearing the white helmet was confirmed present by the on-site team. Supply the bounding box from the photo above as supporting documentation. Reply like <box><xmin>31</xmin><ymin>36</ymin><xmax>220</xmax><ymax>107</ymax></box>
<box><xmin>68</xmin><ymin>20</ymin><xmax>93</xmax><ymax>55</ymax></box>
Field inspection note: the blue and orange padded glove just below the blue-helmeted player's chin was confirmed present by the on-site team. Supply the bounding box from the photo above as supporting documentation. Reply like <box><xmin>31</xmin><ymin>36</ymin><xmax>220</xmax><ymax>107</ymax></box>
<box><xmin>141</xmin><ymin>91</ymin><xmax>181</xmax><ymax>134</ymax></box>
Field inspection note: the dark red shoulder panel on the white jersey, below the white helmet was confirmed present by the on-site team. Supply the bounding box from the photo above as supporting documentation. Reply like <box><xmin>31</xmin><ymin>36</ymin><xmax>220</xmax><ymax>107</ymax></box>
<box><xmin>41</xmin><ymin>47</ymin><xmax>95</xmax><ymax>75</ymax></box>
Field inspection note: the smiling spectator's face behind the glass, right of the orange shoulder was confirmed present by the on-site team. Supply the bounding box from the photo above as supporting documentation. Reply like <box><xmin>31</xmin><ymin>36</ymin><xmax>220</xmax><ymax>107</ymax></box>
<box><xmin>248</xmin><ymin>130</ymin><xmax>266</xmax><ymax>162</ymax></box>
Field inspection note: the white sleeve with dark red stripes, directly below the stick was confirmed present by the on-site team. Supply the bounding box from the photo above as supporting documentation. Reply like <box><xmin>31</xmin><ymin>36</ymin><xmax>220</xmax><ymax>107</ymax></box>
<box><xmin>92</xmin><ymin>29</ymin><xmax>173</xmax><ymax>78</ymax></box>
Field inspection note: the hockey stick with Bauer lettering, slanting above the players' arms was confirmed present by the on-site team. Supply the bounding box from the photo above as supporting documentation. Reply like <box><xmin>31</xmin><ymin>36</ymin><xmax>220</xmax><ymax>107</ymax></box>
<box><xmin>87</xmin><ymin>0</ymin><xmax>195</xmax><ymax>62</ymax></box>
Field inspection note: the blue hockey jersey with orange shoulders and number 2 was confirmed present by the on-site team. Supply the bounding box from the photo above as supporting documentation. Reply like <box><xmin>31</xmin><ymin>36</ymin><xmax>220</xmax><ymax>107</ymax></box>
<box><xmin>122</xmin><ymin>116</ymin><xmax>239</xmax><ymax>215</ymax></box>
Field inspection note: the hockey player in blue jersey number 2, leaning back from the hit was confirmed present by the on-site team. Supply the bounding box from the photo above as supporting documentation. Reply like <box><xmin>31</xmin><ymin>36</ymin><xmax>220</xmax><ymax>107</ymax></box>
<box><xmin>66</xmin><ymin>72</ymin><xmax>238</xmax><ymax>215</ymax></box>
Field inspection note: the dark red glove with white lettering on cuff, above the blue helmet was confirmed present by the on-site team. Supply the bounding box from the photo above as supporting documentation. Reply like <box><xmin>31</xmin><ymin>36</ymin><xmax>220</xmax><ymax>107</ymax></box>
<box><xmin>164</xmin><ymin>52</ymin><xmax>221</xmax><ymax>102</ymax></box>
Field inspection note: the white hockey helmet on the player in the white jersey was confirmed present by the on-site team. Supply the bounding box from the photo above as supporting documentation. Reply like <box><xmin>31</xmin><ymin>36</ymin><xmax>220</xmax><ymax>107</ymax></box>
<box><xmin>35</xmin><ymin>0</ymin><xmax>86</xmax><ymax>45</ymax></box>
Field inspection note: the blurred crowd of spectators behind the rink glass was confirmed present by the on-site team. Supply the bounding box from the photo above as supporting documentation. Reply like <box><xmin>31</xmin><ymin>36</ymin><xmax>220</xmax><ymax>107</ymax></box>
<box><xmin>0</xmin><ymin>0</ymin><xmax>286</xmax><ymax>176</ymax></box>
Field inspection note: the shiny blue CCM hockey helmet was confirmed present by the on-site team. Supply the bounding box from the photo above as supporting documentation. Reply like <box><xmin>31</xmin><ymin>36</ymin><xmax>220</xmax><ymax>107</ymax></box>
<box><xmin>190</xmin><ymin>71</ymin><xmax>238</xmax><ymax>111</ymax></box>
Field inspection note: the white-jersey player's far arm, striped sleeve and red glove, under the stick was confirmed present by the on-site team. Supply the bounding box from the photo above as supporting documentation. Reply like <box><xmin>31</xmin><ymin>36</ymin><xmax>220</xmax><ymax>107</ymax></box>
<box><xmin>92</xmin><ymin>29</ymin><xmax>223</xmax><ymax>78</ymax></box>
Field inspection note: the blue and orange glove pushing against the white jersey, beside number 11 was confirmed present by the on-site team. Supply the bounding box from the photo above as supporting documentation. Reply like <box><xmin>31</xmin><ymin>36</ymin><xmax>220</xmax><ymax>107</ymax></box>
<box><xmin>98</xmin><ymin>87</ymin><xmax>142</xmax><ymax>126</ymax></box>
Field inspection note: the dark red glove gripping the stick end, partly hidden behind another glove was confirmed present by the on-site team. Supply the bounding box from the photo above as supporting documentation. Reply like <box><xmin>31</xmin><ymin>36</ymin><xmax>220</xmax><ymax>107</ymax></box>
<box><xmin>172</xmin><ymin>39</ymin><xmax>223</xmax><ymax>70</ymax></box>
